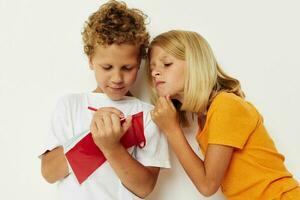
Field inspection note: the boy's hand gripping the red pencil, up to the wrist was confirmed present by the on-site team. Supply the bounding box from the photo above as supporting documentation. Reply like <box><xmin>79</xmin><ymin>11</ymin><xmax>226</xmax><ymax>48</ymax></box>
<box><xmin>90</xmin><ymin>108</ymin><xmax>131</xmax><ymax>152</ymax></box>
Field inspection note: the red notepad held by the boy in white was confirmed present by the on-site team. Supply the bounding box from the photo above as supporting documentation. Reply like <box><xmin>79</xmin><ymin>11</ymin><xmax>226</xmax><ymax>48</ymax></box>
<box><xmin>65</xmin><ymin>112</ymin><xmax>146</xmax><ymax>184</ymax></box>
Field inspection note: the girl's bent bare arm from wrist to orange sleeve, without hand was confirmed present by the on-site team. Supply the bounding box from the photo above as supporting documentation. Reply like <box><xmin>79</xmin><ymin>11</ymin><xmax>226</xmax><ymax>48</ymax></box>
<box><xmin>166</xmin><ymin>129</ymin><xmax>233</xmax><ymax>196</ymax></box>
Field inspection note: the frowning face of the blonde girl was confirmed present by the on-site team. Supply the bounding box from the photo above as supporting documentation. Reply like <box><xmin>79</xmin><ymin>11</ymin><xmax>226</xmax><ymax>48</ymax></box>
<box><xmin>150</xmin><ymin>46</ymin><xmax>186</xmax><ymax>101</ymax></box>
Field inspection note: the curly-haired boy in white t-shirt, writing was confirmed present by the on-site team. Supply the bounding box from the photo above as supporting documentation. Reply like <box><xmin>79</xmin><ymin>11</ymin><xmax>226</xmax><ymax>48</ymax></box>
<box><xmin>41</xmin><ymin>1</ymin><xmax>169</xmax><ymax>200</ymax></box>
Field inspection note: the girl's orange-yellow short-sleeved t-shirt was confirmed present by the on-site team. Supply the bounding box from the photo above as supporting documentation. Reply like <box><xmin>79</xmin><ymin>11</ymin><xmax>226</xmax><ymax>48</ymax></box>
<box><xmin>197</xmin><ymin>92</ymin><xmax>298</xmax><ymax>200</ymax></box>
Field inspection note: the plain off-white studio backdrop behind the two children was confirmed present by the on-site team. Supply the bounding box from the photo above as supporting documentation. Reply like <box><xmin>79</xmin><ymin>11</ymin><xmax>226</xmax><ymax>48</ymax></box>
<box><xmin>0</xmin><ymin>0</ymin><xmax>300</xmax><ymax>200</ymax></box>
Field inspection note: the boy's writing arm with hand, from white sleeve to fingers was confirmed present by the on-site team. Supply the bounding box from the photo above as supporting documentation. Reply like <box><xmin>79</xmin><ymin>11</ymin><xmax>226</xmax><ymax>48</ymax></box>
<box><xmin>91</xmin><ymin>109</ymin><xmax>159</xmax><ymax>198</ymax></box>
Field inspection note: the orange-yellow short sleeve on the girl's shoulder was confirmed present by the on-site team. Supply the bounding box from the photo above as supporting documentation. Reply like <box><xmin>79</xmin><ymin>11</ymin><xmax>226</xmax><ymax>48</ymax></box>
<box><xmin>207</xmin><ymin>94</ymin><xmax>258</xmax><ymax>149</ymax></box>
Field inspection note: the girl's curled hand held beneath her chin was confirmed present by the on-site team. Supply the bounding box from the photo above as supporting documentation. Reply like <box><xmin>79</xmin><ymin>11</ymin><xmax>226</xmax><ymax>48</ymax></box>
<box><xmin>151</xmin><ymin>96</ymin><xmax>180</xmax><ymax>136</ymax></box>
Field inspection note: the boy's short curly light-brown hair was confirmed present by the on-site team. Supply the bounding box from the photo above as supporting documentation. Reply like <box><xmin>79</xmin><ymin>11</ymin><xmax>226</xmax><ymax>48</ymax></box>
<box><xmin>82</xmin><ymin>0</ymin><xmax>150</xmax><ymax>58</ymax></box>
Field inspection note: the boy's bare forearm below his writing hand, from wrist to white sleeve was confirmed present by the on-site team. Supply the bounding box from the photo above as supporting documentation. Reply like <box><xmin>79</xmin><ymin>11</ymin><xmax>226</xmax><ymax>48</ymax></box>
<box><xmin>103</xmin><ymin>145</ymin><xmax>159</xmax><ymax>198</ymax></box>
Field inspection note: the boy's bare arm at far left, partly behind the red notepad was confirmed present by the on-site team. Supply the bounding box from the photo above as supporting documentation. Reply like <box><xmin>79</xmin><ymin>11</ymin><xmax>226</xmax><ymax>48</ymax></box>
<box><xmin>41</xmin><ymin>146</ymin><xmax>69</xmax><ymax>183</ymax></box>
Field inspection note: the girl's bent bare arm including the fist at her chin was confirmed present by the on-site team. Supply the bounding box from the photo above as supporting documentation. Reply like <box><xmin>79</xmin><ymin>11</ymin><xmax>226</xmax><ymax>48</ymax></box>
<box><xmin>151</xmin><ymin>97</ymin><xmax>234</xmax><ymax>196</ymax></box>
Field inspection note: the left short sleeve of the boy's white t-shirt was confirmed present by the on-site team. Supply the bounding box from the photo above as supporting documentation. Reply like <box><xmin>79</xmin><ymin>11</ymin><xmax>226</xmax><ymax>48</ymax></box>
<box><xmin>40</xmin><ymin>97</ymin><xmax>72</xmax><ymax>154</ymax></box>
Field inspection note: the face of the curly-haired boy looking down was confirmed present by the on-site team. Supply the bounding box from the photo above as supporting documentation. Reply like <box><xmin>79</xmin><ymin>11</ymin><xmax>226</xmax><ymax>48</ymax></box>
<box><xmin>89</xmin><ymin>44</ymin><xmax>140</xmax><ymax>100</ymax></box>
